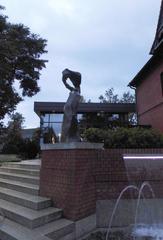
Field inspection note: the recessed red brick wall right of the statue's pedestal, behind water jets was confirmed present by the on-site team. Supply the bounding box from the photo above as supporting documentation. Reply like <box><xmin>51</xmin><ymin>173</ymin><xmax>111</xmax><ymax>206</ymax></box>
<box><xmin>95</xmin><ymin>149</ymin><xmax>163</xmax><ymax>200</ymax></box>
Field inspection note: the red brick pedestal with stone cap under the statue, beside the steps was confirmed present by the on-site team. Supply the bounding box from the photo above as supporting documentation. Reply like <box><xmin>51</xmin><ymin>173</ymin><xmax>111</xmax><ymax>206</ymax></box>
<box><xmin>40</xmin><ymin>143</ymin><xmax>102</xmax><ymax>220</ymax></box>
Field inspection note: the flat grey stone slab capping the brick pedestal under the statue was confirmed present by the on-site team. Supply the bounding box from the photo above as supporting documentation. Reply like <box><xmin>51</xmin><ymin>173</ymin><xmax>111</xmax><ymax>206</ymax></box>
<box><xmin>41</xmin><ymin>142</ymin><xmax>103</xmax><ymax>150</ymax></box>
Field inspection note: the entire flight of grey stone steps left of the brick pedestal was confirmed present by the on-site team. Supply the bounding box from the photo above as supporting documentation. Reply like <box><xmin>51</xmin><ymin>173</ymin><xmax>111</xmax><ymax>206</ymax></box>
<box><xmin>0</xmin><ymin>161</ymin><xmax>75</xmax><ymax>240</ymax></box>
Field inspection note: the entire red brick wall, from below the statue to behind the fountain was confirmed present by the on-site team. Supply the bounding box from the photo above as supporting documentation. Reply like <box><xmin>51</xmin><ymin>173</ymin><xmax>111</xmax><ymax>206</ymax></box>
<box><xmin>40</xmin><ymin>149</ymin><xmax>163</xmax><ymax>220</ymax></box>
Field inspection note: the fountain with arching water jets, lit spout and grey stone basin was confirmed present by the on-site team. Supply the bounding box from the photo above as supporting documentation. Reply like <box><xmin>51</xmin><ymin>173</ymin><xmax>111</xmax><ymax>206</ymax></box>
<box><xmin>81</xmin><ymin>154</ymin><xmax>163</xmax><ymax>240</ymax></box>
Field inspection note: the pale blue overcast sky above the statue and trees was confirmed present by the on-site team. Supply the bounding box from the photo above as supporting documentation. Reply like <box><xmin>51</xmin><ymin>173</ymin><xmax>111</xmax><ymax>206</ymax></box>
<box><xmin>0</xmin><ymin>0</ymin><xmax>161</xmax><ymax>128</ymax></box>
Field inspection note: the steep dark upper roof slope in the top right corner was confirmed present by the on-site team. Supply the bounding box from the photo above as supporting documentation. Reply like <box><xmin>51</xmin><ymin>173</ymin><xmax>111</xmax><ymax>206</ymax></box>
<box><xmin>150</xmin><ymin>0</ymin><xmax>163</xmax><ymax>54</ymax></box>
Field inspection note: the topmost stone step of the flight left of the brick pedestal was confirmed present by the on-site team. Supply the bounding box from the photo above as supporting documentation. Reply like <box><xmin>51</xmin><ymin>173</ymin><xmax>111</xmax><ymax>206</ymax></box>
<box><xmin>3</xmin><ymin>161</ymin><xmax>40</xmax><ymax>170</ymax></box>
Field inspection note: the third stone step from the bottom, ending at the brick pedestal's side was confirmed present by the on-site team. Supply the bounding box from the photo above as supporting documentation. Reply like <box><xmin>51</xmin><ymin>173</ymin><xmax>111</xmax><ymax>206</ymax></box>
<box><xmin>0</xmin><ymin>187</ymin><xmax>52</xmax><ymax>210</ymax></box>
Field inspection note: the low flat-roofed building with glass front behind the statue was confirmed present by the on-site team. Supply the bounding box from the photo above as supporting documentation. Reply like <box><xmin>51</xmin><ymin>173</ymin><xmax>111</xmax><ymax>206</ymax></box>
<box><xmin>34</xmin><ymin>102</ymin><xmax>135</xmax><ymax>143</ymax></box>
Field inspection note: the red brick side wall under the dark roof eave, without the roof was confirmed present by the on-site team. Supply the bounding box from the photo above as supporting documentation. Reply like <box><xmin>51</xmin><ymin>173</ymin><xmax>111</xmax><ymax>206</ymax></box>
<box><xmin>136</xmin><ymin>61</ymin><xmax>163</xmax><ymax>132</ymax></box>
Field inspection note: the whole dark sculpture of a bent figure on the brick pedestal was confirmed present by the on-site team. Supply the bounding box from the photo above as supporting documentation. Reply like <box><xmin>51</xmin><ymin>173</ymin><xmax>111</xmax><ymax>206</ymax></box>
<box><xmin>61</xmin><ymin>68</ymin><xmax>81</xmax><ymax>143</ymax></box>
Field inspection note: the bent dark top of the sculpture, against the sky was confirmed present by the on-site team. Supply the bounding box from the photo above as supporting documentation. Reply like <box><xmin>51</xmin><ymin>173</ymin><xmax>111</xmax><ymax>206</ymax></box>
<box><xmin>62</xmin><ymin>68</ymin><xmax>81</xmax><ymax>88</ymax></box>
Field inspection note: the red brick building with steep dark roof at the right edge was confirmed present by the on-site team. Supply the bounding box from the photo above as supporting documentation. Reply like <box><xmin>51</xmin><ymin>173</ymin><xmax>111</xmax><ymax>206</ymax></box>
<box><xmin>129</xmin><ymin>0</ymin><xmax>163</xmax><ymax>133</ymax></box>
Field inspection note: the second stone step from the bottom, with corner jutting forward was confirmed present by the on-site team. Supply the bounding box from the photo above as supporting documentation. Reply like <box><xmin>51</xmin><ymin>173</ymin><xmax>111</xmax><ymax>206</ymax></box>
<box><xmin>0</xmin><ymin>199</ymin><xmax>62</xmax><ymax>229</ymax></box>
